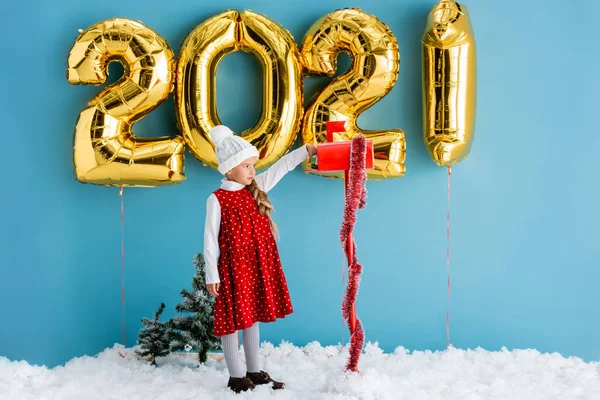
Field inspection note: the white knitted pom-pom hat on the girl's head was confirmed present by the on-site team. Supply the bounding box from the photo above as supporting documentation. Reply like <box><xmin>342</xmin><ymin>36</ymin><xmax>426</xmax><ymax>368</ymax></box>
<box><xmin>208</xmin><ymin>125</ymin><xmax>258</xmax><ymax>175</ymax></box>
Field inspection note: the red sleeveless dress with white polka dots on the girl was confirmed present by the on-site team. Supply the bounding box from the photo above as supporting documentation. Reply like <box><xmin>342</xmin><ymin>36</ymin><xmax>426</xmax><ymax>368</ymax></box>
<box><xmin>214</xmin><ymin>188</ymin><xmax>293</xmax><ymax>336</ymax></box>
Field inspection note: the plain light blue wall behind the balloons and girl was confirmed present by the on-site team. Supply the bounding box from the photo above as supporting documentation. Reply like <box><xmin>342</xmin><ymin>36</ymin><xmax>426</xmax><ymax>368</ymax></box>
<box><xmin>0</xmin><ymin>0</ymin><xmax>600</xmax><ymax>365</ymax></box>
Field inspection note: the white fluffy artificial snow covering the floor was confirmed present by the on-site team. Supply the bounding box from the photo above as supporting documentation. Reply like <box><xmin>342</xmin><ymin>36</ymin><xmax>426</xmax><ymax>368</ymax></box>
<box><xmin>0</xmin><ymin>342</ymin><xmax>600</xmax><ymax>400</ymax></box>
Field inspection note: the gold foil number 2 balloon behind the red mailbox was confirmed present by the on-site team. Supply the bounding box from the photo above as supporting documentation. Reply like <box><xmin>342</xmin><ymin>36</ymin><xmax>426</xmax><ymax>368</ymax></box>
<box><xmin>301</xmin><ymin>8</ymin><xmax>406</xmax><ymax>179</ymax></box>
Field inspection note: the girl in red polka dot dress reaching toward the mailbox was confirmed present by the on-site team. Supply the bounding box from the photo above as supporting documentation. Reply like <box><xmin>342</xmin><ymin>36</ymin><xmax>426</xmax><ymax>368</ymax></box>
<box><xmin>204</xmin><ymin>125</ymin><xmax>317</xmax><ymax>393</ymax></box>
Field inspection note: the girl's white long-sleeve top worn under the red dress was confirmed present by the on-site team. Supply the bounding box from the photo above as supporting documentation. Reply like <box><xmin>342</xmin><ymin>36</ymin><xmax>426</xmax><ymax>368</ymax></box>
<box><xmin>204</xmin><ymin>146</ymin><xmax>308</xmax><ymax>285</ymax></box>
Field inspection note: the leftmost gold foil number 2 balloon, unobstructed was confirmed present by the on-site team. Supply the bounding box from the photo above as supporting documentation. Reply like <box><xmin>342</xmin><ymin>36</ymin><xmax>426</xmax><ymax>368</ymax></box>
<box><xmin>67</xmin><ymin>18</ymin><xmax>185</xmax><ymax>186</ymax></box>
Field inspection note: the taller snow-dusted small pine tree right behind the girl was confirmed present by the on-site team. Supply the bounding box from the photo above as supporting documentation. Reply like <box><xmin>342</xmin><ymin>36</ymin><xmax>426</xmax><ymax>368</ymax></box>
<box><xmin>169</xmin><ymin>253</ymin><xmax>221</xmax><ymax>363</ymax></box>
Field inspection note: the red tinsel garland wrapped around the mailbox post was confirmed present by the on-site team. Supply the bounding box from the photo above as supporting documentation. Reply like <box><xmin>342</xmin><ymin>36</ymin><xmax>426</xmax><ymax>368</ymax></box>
<box><xmin>340</xmin><ymin>135</ymin><xmax>367</xmax><ymax>371</ymax></box>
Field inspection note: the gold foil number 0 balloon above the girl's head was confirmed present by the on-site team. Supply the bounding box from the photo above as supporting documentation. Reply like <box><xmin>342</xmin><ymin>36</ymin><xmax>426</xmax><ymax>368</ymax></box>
<box><xmin>176</xmin><ymin>10</ymin><xmax>303</xmax><ymax>169</ymax></box>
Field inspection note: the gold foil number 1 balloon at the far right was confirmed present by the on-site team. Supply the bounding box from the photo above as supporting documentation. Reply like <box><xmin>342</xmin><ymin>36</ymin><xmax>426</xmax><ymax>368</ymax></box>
<box><xmin>421</xmin><ymin>0</ymin><xmax>477</xmax><ymax>167</ymax></box>
